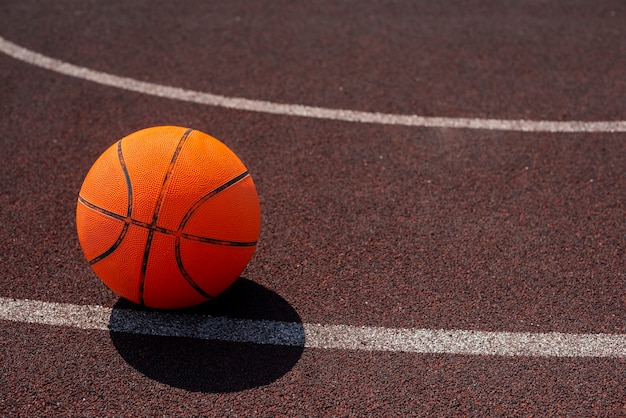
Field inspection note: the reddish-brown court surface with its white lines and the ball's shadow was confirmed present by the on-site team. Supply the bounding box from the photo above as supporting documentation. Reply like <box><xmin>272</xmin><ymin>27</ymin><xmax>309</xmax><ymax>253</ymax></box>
<box><xmin>0</xmin><ymin>0</ymin><xmax>626</xmax><ymax>417</ymax></box>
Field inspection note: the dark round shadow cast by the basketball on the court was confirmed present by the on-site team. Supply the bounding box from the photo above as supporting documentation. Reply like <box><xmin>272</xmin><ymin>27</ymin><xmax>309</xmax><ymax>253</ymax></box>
<box><xmin>109</xmin><ymin>278</ymin><xmax>304</xmax><ymax>393</ymax></box>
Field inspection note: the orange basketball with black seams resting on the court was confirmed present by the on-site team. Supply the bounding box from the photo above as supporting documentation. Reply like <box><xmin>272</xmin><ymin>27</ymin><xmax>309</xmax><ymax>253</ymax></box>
<box><xmin>76</xmin><ymin>126</ymin><xmax>261</xmax><ymax>309</ymax></box>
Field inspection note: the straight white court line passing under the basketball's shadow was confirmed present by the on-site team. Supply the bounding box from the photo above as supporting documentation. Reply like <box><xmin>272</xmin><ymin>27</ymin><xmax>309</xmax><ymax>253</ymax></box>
<box><xmin>0</xmin><ymin>298</ymin><xmax>626</xmax><ymax>358</ymax></box>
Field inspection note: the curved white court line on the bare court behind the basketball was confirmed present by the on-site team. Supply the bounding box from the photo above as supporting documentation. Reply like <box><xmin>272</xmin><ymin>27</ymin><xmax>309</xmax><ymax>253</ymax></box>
<box><xmin>0</xmin><ymin>37</ymin><xmax>626</xmax><ymax>133</ymax></box>
